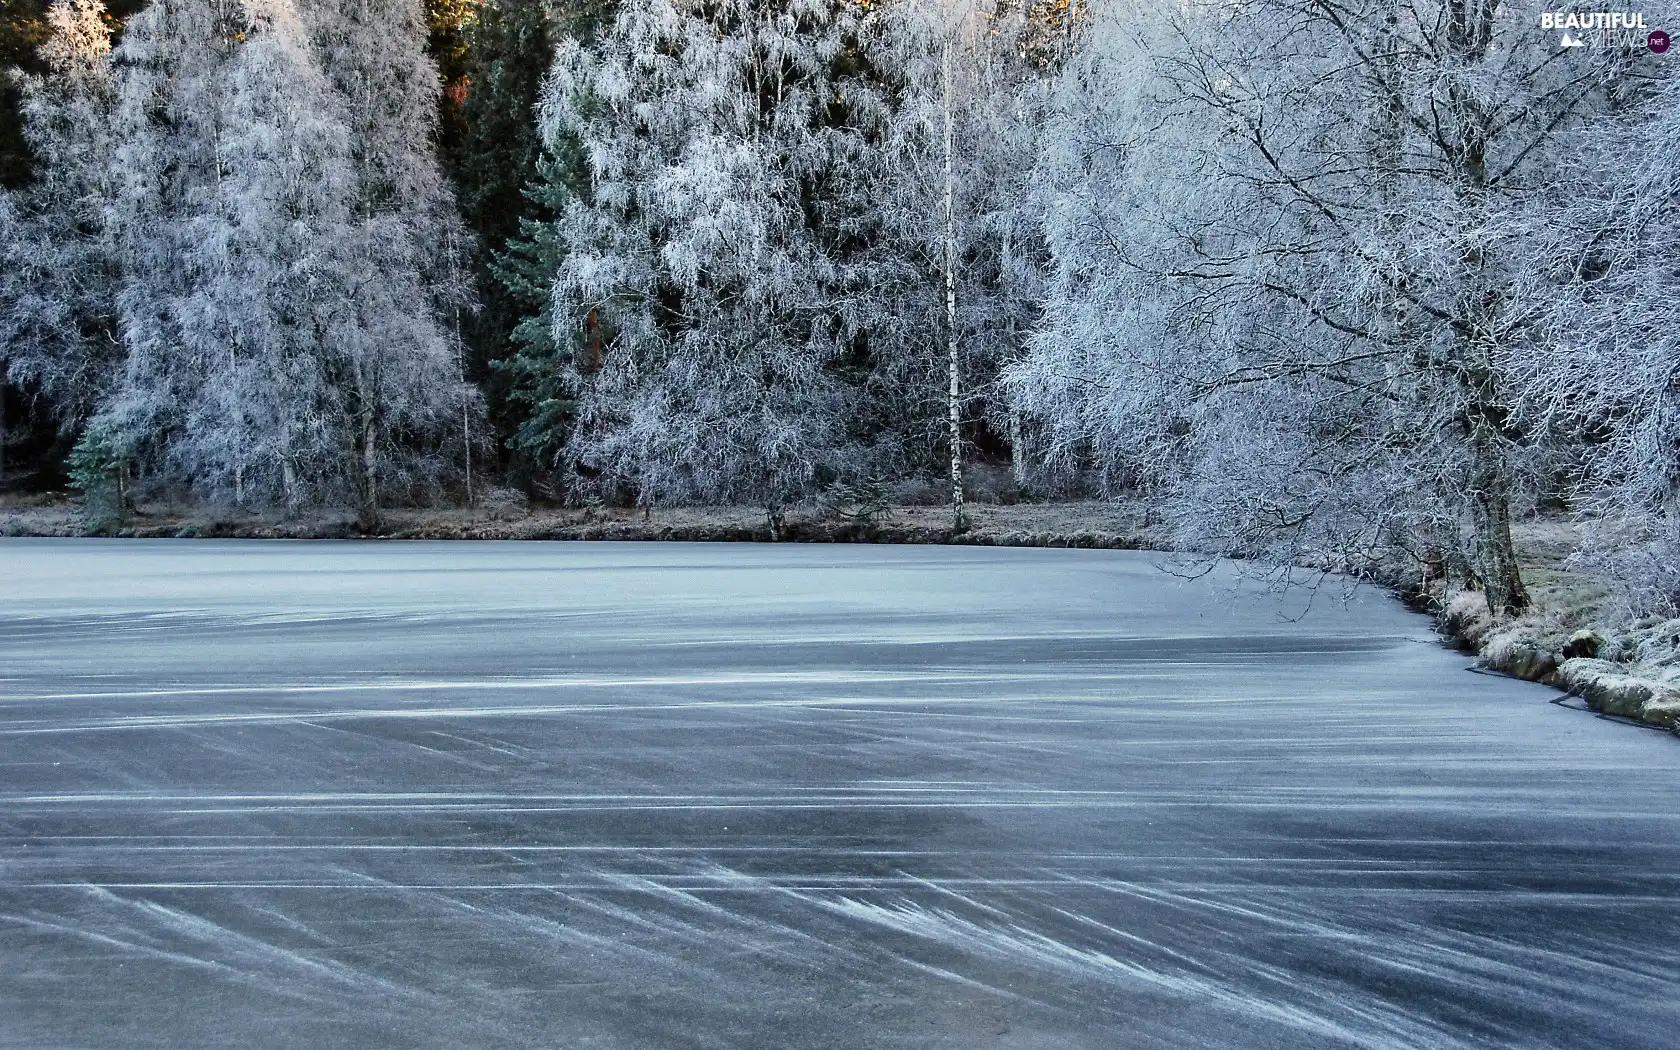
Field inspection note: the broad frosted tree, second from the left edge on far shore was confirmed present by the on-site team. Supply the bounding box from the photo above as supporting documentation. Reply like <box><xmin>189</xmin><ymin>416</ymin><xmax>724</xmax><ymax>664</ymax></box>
<box><xmin>94</xmin><ymin>0</ymin><xmax>351</xmax><ymax>506</ymax></box>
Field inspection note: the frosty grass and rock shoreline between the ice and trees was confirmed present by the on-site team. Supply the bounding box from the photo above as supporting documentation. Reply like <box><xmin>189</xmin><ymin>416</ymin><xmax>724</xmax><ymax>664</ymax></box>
<box><xmin>0</xmin><ymin>501</ymin><xmax>1680</xmax><ymax>734</ymax></box>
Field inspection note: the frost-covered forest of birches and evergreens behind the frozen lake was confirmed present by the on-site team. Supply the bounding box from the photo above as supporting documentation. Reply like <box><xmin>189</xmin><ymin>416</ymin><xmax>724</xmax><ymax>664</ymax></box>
<box><xmin>0</xmin><ymin>0</ymin><xmax>1680</xmax><ymax>613</ymax></box>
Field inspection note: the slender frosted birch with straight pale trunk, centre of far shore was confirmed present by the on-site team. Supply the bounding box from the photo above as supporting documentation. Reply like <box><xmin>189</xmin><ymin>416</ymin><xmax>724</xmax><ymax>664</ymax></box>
<box><xmin>872</xmin><ymin>0</ymin><xmax>1043</xmax><ymax>517</ymax></box>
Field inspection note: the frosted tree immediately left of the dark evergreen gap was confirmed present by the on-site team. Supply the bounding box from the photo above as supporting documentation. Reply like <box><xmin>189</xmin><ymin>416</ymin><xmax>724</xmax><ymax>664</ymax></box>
<box><xmin>304</xmin><ymin>0</ymin><xmax>480</xmax><ymax>519</ymax></box>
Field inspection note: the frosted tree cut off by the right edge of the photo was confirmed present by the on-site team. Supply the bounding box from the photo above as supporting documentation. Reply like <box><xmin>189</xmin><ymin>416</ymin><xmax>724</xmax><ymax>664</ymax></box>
<box><xmin>1509</xmin><ymin>55</ymin><xmax>1680</xmax><ymax>613</ymax></box>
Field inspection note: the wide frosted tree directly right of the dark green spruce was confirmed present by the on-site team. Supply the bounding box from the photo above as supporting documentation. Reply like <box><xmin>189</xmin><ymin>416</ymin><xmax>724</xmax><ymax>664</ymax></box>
<box><xmin>543</xmin><ymin>0</ymin><xmax>880</xmax><ymax>524</ymax></box>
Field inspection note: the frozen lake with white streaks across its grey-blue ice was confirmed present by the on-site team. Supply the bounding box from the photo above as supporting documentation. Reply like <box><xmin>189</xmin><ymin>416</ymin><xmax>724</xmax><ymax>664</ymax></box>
<box><xmin>0</xmin><ymin>539</ymin><xmax>1680</xmax><ymax>1050</ymax></box>
